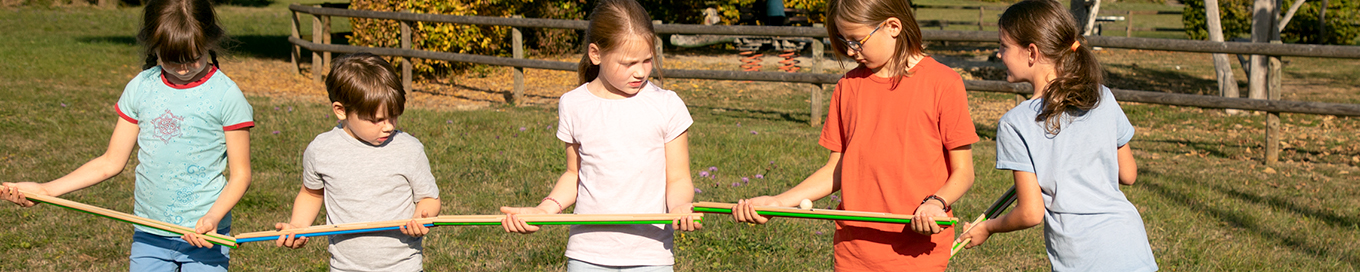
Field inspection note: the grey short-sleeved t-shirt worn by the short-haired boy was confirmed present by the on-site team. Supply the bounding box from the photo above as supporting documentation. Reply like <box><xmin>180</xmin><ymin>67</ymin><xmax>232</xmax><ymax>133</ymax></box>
<box><xmin>302</xmin><ymin>126</ymin><xmax>439</xmax><ymax>271</ymax></box>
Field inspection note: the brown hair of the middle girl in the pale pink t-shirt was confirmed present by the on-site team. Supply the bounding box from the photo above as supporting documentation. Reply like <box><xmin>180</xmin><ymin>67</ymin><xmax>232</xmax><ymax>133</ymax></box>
<box><xmin>577</xmin><ymin>0</ymin><xmax>661</xmax><ymax>84</ymax></box>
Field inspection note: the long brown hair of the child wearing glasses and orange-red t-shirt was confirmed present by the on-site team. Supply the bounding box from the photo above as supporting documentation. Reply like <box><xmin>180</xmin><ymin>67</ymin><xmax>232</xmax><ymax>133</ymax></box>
<box><xmin>827</xmin><ymin>0</ymin><xmax>925</xmax><ymax>84</ymax></box>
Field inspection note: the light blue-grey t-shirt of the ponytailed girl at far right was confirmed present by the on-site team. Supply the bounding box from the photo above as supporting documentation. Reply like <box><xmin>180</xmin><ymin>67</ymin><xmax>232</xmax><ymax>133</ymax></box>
<box><xmin>997</xmin><ymin>87</ymin><xmax>1157</xmax><ymax>271</ymax></box>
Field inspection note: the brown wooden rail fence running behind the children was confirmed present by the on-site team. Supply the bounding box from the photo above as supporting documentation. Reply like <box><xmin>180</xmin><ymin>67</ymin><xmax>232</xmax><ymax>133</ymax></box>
<box><xmin>288</xmin><ymin>4</ymin><xmax>1360</xmax><ymax>162</ymax></box>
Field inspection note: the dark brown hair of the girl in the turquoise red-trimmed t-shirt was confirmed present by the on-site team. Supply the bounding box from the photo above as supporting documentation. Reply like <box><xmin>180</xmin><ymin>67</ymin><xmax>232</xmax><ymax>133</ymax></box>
<box><xmin>137</xmin><ymin>0</ymin><xmax>227</xmax><ymax>69</ymax></box>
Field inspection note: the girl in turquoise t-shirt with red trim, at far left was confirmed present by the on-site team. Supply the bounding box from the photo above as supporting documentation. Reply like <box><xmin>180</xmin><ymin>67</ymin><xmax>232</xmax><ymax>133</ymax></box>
<box><xmin>0</xmin><ymin>0</ymin><xmax>254</xmax><ymax>271</ymax></box>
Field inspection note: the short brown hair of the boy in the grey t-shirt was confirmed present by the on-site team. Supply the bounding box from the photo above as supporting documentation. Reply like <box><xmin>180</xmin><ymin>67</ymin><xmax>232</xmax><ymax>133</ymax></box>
<box><xmin>326</xmin><ymin>53</ymin><xmax>407</xmax><ymax>120</ymax></box>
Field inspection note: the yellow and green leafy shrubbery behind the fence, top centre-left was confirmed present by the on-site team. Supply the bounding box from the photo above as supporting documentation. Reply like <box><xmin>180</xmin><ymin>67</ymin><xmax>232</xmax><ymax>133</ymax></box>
<box><xmin>345</xmin><ymin>0</ymin><xmax>826</xmax><ymax>76</ymax></box>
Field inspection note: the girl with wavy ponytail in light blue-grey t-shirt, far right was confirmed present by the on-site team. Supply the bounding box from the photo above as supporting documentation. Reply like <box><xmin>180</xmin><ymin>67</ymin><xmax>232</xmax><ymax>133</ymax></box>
<box><xmin>959</xmin><ymin>0</ymin><xmax>1157</xmax><ymax>271</ymax></box>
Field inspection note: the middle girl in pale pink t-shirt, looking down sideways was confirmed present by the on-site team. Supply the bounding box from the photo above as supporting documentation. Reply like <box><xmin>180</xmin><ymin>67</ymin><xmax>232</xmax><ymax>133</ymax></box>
<box><xmin>500</xmin><ymin>0</ymin><xmax>703</xmax><ymax>271</ymax></box>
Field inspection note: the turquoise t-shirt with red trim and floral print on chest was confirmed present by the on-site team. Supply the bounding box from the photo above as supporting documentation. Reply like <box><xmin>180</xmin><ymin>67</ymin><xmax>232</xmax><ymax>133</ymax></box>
<box><xmin>114</xmin><ymin>67</ymin><xmax>254</xmax><ymax>237</ymax></box>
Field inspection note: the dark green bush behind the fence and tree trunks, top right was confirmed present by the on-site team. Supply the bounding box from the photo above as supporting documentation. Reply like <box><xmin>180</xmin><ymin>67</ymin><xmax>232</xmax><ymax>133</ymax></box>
<box><xmin>1182</xmin><ymin>0</ymin><xmax>1360</xmax><ymax>45</ymax></box>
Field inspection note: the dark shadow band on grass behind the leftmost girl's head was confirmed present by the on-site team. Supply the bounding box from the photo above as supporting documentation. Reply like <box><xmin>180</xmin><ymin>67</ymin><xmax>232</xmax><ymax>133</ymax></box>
<box><xmin>76</xmin><ymin>33</ymin><xmax>350</xmax><ymax>61</ymax></box>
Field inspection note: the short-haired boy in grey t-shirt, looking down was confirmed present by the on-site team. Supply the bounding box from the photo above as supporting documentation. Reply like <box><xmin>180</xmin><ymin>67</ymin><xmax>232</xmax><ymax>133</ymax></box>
<box><xmin>265</xmin><ymin>53</ymin><xmax>439</xmax><ymax>271</ymax></box>
